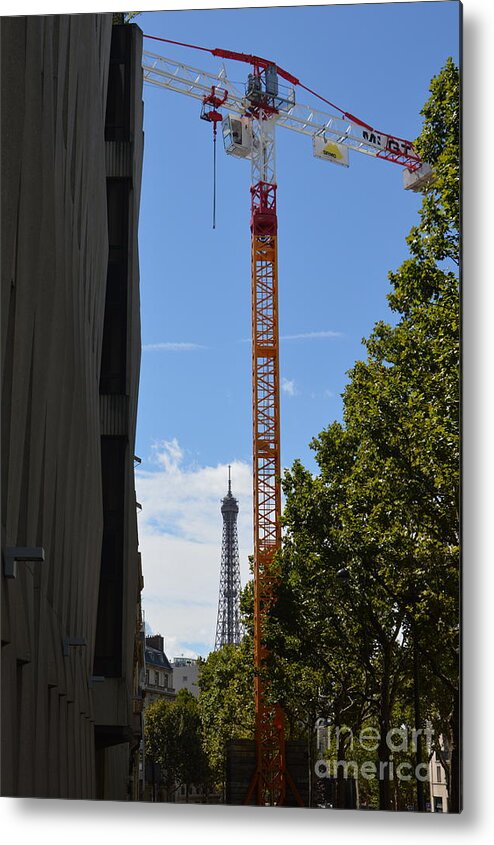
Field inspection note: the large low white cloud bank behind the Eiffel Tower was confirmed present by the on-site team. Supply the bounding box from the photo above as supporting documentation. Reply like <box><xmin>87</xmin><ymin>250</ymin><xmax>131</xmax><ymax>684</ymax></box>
<box><xmin>136</xmin><ymin>439</ymin><xmax>252</xmax><ymax>658</ymax></box>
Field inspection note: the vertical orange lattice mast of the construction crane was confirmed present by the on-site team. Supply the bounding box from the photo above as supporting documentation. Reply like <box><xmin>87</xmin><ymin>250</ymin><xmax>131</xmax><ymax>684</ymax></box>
<box><xmin>249</xmin><ymin>108</ymin><xmax>286</xmax><ymax>805</ymax></box>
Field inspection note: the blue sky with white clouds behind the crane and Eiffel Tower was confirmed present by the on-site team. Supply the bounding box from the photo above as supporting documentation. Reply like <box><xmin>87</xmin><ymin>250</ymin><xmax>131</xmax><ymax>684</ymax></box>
<box><xmin>136</xmin><ymin>2</ymin><xmax>459</xmax><ymax>657</ymax></box>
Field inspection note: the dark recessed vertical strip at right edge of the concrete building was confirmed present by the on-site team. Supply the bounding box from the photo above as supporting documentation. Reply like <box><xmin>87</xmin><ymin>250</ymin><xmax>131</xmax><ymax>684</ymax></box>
<box><xmin>94</xmin><ymin>25</ymin><xmax>143</xmax><ymax>799</ymax></box>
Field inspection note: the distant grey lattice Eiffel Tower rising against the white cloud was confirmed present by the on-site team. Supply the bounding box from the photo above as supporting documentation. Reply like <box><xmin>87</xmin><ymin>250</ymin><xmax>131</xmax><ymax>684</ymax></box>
<box><xmin>214</xmin><ymin>467</ymin><xmax>242</xmax><ymax>650</ymax></box>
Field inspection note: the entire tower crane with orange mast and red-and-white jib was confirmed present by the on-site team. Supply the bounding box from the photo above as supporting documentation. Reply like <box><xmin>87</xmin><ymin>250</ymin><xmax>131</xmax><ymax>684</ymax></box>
<box><xmin>143</xmin><ymin>36</ymin><xmax>432</xmax><ymax>805</ymax></box>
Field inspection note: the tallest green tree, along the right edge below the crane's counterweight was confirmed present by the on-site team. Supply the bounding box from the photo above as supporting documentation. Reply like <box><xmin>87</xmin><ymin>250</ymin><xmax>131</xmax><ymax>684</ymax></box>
<box><xmin>345</xmin><ymin>54</ymin><xmax>460</xmax><ymax>811</ymax></box>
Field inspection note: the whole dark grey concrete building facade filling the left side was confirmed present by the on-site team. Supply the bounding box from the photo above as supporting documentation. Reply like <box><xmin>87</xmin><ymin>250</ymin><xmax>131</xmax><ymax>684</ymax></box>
<box><xmin>0</xmin><ymin>14</ymin><xmax>144</xmax><ymax>800</ymax></box>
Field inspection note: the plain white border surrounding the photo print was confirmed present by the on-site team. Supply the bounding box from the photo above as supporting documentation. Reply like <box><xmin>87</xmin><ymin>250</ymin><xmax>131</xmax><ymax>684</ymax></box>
<box><xmin>0</xmin><ymin>0</ymin><xmax>494</xmax><ymax>845</ymax></box>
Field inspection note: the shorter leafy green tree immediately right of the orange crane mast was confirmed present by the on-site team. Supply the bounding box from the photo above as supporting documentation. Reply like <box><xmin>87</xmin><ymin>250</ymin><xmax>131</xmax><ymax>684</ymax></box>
<box><xmin>270</xmin><ymin>452</ymin><xmax>407</xmax><ymax>809</ymax></box>
